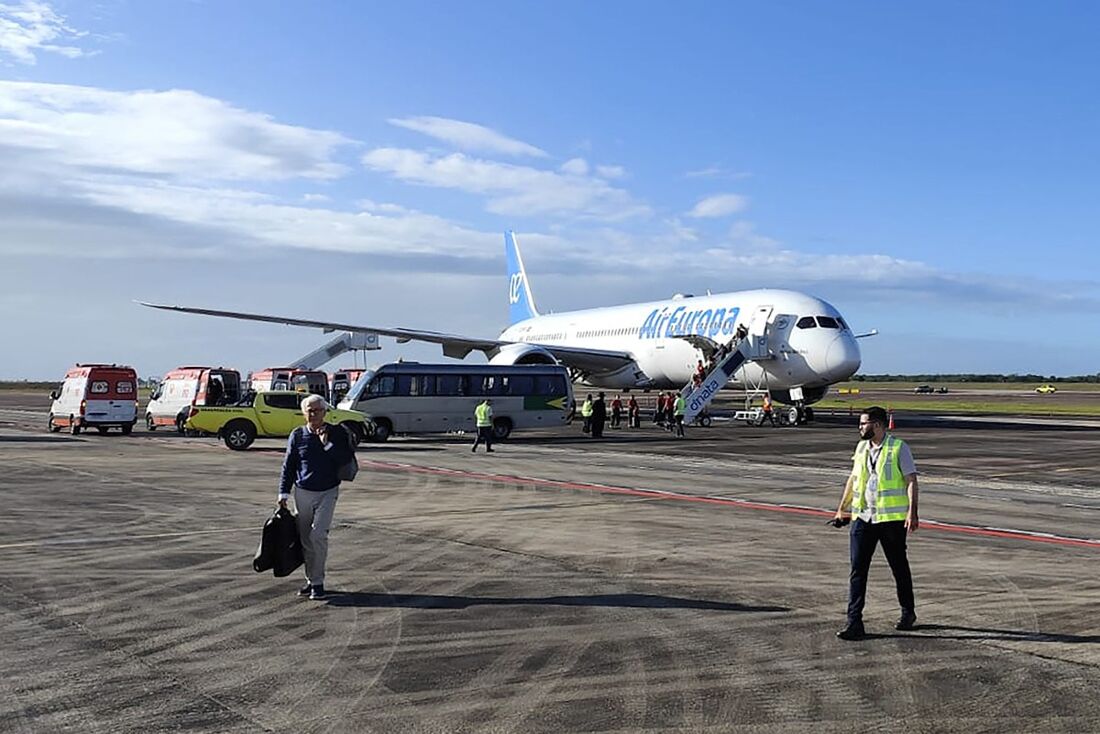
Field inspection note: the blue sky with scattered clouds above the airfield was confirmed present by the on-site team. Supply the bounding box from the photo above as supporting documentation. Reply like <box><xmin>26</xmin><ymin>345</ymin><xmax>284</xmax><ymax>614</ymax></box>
<box><xmin>0</xmin><ymin>0</ymin><xmax>1100</xmax><ymax>379</ymax></box>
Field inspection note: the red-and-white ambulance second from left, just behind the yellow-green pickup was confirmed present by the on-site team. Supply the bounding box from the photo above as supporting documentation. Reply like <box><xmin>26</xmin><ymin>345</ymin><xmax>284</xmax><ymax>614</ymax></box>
<box><xmin>145</xmin><ymin>366</ymin><xmax>241</xmax><ymax>432</ymax></box>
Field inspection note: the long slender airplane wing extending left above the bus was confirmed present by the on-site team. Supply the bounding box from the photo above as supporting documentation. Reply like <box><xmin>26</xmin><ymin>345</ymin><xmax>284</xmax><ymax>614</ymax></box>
<box><xmin>136</xmin><ymin>300</ymin><xmax>634</xmax><ymax>373</ymax></box>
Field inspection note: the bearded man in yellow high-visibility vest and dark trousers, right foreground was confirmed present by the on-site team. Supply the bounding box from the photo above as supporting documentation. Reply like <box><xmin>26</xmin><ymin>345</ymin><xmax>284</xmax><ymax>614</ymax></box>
<box><xmin>832</xmin><ymin>406</ymin><xmax>920</xmax><ymax>640</ymax></box>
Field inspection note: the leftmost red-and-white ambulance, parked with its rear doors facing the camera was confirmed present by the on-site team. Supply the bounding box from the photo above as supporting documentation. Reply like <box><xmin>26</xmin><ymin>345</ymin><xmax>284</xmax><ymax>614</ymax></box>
<box><xmin>46</xmin><ymin>364</ymin><xmax>138</xmax><ymax>435</ymax></box>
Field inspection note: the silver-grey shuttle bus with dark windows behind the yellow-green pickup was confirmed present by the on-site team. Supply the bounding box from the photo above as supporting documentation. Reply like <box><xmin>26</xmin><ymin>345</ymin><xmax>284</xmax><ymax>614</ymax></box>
<box><xmin>339</xmin><ymin>362</ymin><xmax>573</xmax><ymax>441</ymax></box>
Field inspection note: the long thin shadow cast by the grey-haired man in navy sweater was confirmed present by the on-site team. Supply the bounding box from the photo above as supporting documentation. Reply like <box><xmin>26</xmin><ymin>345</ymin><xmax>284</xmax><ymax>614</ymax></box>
<box><xmin>328</xmin><ymin>591</ymin><xmax>791</xmax><ymax>612</ymax></box>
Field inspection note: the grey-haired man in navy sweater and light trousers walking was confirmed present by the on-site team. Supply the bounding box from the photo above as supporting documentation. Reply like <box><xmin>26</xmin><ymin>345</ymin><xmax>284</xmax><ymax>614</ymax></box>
<box><xmin>278</xmin><ymin>395</ymin><xmax>354</xmax><ymax>600</ymax></box>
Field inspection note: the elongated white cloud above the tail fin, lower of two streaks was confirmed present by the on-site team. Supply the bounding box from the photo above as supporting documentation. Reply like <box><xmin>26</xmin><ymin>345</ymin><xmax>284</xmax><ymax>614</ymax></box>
<box><xmin>363</xmin><ymin>147</ymin><xmax>649</xmax><ymax>220</ymax></box>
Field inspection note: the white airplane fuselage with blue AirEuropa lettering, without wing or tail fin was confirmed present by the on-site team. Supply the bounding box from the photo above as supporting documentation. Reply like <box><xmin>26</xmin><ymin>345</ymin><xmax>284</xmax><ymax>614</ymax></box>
<box><xmin>501</xmin><ymin>289</ymin><xmax>860</xmax><ymax>398</ymax></box>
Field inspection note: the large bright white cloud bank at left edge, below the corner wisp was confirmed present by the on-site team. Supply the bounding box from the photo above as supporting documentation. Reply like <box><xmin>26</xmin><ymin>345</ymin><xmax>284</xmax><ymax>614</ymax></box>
<box><xmin>0</xmin><ymin>80</ymin><xmax>352</xmax><ymax>180</ymax></box>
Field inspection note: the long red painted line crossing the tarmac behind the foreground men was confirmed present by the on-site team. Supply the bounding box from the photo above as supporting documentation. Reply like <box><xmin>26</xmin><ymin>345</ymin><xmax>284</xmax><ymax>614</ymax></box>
<box><xmin>360</xmin><ymin>461</ymin><xmax>1100</xmax><ymax>550</ymax></box>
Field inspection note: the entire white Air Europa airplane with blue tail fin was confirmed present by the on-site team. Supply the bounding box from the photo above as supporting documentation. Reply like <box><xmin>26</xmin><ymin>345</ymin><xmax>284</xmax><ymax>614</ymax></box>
<box><xmin>139</xmin><ymin>231</ymin><xmax>858</xmax><ymax>407</ymax></box>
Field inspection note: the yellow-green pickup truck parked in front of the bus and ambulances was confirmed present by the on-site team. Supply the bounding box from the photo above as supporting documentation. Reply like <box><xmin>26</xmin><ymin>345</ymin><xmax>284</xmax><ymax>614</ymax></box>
<box><xmin>184</xmin><ymin>391</ymin><xmax>374</xmax><ymax>451</ymax></box>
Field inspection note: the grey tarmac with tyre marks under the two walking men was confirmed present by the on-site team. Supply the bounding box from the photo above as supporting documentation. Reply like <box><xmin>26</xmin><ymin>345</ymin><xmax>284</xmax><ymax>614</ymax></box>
<box><xmin>0</xmin><ymin>394</ymin><xmax>1100</xmax><ymax>732</ymax></box>
